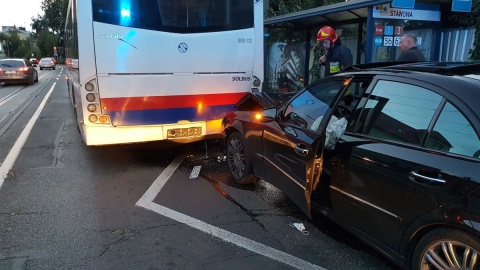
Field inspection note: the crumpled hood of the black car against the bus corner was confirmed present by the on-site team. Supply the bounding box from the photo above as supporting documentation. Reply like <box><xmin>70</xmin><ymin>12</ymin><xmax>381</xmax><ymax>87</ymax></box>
<box><xmin>235</xmin><ymin>92</ymin><xmax>296</xmax><ymax>111</ymax></box>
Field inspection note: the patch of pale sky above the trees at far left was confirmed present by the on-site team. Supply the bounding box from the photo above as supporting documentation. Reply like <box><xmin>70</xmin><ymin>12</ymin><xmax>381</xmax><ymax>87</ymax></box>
<box><xmin>0</xmin><ymin>0</ymin><xmax>43</xmax><ymax>31</ymax></box>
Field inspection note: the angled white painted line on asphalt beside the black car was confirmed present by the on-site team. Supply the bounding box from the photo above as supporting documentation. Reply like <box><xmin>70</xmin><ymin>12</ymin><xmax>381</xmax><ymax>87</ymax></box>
<box><xmin>135</xmin><ymin>156</ymin><xmax>326</xmax><ymax>270</ymax></box>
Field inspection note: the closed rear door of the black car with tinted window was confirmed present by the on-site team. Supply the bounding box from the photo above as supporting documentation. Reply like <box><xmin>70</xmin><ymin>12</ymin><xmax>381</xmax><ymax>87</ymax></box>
<box><xmin>330</xmin><ymin>77</ymin><xmax>480</xmax><ymax>250</ymax></box>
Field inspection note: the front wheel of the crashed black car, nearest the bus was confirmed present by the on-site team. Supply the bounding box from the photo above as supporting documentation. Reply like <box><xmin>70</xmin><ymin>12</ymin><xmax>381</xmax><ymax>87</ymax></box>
<box><xmin>226</xmin><ymin>132</ymin><xmax>258</xmax><ymax>184</ymax></box>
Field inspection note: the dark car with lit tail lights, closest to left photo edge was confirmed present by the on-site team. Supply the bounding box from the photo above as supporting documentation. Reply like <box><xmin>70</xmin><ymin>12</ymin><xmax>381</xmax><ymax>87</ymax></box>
<box><xmin>0</xmin><ymin>58</ymin><xmax>38</xmax><ymax>85</ymax></box>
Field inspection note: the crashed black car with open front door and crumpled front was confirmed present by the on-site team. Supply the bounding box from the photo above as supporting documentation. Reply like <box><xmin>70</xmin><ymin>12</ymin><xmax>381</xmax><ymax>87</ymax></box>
<box><xmin>223</xmin><ymin>62</ymin><xmax>480</xmax><ymax>269</ymax></box>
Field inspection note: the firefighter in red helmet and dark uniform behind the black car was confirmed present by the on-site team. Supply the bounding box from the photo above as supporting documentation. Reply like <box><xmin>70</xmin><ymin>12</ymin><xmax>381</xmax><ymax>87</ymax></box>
<box><xmin>317</xmin><ymin>26</ymin><xmax>353</xmax><ymax>77</ymax></box>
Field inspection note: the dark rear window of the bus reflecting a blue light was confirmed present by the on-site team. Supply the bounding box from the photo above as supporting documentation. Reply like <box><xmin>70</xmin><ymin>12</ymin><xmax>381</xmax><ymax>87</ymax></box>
<box><xmin>92</xmin><ymin>0</ymin><xmax>254</xmax><ymax>33</ymax></box>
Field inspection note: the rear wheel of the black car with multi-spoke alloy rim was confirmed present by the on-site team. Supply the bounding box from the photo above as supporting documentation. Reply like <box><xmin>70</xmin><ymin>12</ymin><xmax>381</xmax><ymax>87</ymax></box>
<box><xmin>411</xmin><ymin>228</ymin><xmax>480</xmax><ymax>270</ymax></box>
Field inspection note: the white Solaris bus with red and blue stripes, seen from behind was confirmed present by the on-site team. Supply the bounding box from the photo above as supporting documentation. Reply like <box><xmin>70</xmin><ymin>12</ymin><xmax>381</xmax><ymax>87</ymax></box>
<box><xmin>64</xmin><ymin>0</ymin><xmax>264</xmax><ymax>145</ymax></box>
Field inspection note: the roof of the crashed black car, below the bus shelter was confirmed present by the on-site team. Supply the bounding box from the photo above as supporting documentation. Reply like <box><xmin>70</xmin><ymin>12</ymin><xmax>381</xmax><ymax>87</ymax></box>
<box><xmin>336</xmin><ymin>62</ymin><xmax>480</xmax><ymax>115</ymax></box>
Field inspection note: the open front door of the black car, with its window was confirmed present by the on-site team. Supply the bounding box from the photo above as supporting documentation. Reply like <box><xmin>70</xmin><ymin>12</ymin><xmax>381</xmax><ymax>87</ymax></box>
<box><xmin>262</xmin><ymin>78</ymin><xmax>346</xmax><ymax>216</ymax></box>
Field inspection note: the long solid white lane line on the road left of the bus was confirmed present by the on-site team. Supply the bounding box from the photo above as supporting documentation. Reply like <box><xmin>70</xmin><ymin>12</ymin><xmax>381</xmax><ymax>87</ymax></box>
<box><xmin>0</xmin><ymin>83</ymin><xmax>57</xmax><ymax>188</ymax></box>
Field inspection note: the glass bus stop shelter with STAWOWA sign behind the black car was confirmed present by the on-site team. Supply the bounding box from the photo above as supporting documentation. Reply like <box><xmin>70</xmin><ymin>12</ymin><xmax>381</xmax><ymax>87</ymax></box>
<box><xmin>264</xmin><ymin>0</ymin><xmax>462</xmax><ymax>92</ymax></box>
